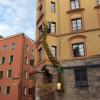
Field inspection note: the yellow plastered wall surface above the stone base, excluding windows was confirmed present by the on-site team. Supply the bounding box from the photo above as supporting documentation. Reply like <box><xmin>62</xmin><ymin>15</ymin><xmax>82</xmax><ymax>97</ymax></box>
<box><xmin>37</xmin><ymin>0</ymin><xmax>100</xmax><ymax>60</ymax></box>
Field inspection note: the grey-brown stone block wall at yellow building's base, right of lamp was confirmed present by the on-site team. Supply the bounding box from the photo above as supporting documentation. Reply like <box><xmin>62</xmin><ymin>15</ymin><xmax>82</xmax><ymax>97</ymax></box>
<box><xmin>57</xmin><ymin>58</ymin><xmax>100</xmax><ymax>100</ymax></box>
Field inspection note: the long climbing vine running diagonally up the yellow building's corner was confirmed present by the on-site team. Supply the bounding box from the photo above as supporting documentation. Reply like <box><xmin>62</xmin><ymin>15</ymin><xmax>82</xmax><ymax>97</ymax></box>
<box><xmin>42</xmin><ymin>25</ymin><xmax>64</xmax><ymax>90</ymax></box>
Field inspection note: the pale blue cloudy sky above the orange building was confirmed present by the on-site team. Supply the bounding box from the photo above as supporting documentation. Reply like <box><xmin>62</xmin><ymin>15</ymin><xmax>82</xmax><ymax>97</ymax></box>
<box><xmin>0</xmin><ymin>0</ymin><xmax>36</xmax><ymax>39</ymax></box>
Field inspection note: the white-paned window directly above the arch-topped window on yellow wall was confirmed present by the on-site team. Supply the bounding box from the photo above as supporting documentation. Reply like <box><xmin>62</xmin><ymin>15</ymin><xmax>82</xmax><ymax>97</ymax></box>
<box><xmin>72</xmin><ymin>18</ymin><xmax>82</xmax><ymax>31</ymax></box>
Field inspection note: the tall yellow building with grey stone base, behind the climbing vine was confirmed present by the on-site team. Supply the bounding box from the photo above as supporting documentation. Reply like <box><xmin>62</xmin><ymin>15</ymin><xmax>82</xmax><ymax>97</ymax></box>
<box><xmin>36</xmin><ymin>0</ymin><xmax>100</xmax><ymax>100</ymax></box>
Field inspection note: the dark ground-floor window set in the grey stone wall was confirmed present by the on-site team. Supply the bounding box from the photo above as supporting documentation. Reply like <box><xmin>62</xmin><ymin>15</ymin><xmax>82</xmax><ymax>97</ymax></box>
<box><xmin>74</xmin><ymin>69</ymin><xmax>88</xmax><ymax>87</ymax></box>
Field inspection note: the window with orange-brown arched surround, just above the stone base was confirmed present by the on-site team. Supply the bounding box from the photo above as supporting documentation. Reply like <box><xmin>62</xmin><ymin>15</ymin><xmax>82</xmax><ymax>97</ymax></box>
<box><xmin>69</xmin><ymin>35</ymin><xmax>86</xmax><ymax>57</ymax></box>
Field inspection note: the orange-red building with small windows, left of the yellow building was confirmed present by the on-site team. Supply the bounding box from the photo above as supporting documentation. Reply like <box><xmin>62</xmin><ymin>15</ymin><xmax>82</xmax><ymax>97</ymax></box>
<box><xmin>0</xmin><ymin>33</ymin><xmax>36</xmax><ymax>100</ymax></box>
